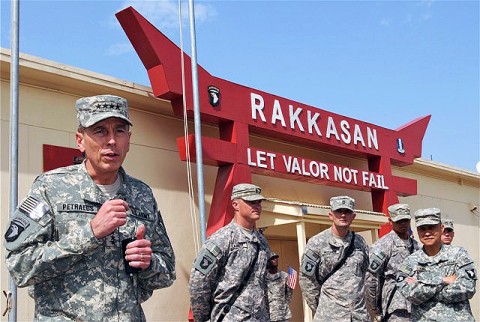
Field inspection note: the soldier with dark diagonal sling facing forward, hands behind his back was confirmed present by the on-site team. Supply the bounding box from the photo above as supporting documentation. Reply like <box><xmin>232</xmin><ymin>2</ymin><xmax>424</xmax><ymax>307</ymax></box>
<box><xmin>299</xmin><ymin>196</ymin><xmax>370</xmax><ymax>322</ymax></box>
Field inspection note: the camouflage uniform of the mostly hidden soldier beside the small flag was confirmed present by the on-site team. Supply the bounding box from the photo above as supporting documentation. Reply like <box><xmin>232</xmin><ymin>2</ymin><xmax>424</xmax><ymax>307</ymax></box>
<box><xmin>267</xmin><ymin>271</ymin><xmax>293</xmax><ymax>321</ymax></box>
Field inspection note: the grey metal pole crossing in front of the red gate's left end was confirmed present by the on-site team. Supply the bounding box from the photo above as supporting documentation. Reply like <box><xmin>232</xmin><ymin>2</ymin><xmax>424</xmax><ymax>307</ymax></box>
<box><xmin>188</xmin><ymin>0</ymin><xmax>207</xmax><ymax>243</ymax></box>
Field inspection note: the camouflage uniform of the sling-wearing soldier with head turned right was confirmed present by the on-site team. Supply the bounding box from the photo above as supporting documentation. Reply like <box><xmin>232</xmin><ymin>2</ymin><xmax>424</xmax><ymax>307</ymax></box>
<box><xmin>189</xmin><ymin>221</ymin><xmax>270</xmax><ymax>322</ymax></box>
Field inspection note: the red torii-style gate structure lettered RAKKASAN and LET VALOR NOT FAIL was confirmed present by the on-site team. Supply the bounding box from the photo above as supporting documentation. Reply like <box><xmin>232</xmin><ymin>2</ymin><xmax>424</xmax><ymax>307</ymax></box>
<box><xmin>116</xmin><ymin>7</ymin><xmax>430</xmax><ymax>235</ymax></box>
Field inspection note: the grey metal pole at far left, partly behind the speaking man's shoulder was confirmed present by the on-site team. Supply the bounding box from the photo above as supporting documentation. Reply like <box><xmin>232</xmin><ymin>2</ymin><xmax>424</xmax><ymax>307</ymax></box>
<box><xmin>8</xmin><ymin>0</ymin><xmax>20</xmax><ymax>322</ymax></box>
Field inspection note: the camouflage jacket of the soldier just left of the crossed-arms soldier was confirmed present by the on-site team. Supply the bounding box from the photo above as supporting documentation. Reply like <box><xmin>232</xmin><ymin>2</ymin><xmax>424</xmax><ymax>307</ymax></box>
<box><xmin>365</xmin><ymin>230</ymin><xmax>418</xmax><ymax>316</ymax></box>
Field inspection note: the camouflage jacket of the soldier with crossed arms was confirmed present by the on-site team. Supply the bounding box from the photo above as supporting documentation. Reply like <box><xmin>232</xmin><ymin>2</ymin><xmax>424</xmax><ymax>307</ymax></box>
<box><xmin>397</xmin><ymin>245</ymin><xmax>477</xmax><ymax>322</ymax></box>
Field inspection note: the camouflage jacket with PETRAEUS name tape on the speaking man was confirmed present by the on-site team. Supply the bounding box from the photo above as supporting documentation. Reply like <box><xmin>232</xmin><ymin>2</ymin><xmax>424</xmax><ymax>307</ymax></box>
<box><xmin>5</xmin><ymin>163</ymin><xmax>175</xmax><ymax>321</ymax></box>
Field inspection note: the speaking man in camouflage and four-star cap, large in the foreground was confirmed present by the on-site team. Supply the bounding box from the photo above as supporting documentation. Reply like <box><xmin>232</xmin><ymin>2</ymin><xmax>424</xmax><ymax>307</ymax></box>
<box><xmin>5</xmin><ymin>95</ymin><xmax>175</xmax><ymax>322</ymax></box>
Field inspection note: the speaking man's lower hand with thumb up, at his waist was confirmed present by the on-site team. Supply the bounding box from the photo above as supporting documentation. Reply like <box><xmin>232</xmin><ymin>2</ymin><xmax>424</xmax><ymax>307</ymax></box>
<box><xmin>125</xmin><ymin>225</ymin><xmax>152</xmax><ymax>270</ymax></box>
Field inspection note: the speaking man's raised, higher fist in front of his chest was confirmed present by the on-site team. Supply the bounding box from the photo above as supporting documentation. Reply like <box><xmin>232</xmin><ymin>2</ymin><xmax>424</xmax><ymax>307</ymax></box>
<box><xmin>90</xmin><ymin>199</ymin><xmax>129</xmax><ymax>239</ymax></box>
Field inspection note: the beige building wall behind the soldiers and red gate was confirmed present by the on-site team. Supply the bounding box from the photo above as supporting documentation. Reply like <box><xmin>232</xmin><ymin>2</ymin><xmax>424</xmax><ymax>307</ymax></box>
<box><xmin>0</xmin><ymin>49</ymin><xmax>480</xmax><ymax>321</ymax></box>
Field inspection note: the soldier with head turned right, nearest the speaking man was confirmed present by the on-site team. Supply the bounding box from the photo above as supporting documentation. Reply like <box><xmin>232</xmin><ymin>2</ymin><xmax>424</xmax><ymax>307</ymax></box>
<box><xmin>189</xmin><ymin>184</ymin><xmax>270</xmax><ymax>322</ymax></box>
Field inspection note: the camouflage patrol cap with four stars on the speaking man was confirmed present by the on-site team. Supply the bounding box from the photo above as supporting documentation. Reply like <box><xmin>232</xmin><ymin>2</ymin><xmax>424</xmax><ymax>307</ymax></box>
<box><xmin>76</xmin><ymin>95</ymin><xmax>132</xmax><ymax>128</ymax></box>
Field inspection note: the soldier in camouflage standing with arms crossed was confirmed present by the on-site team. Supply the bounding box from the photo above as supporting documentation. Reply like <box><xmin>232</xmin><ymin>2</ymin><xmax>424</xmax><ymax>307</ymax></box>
<box><xmin>397</xmin><ymin>208</ymin><xmax>477</xmax><ymax>322</ymax></box>
